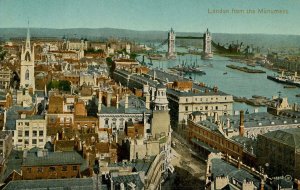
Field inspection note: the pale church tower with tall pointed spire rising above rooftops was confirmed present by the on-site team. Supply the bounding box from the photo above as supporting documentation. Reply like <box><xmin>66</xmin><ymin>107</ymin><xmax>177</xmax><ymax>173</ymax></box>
<box><xmin>20</xmin><ymin>24</ymin><xmax>35</xmax><ymax>93</ymax></box>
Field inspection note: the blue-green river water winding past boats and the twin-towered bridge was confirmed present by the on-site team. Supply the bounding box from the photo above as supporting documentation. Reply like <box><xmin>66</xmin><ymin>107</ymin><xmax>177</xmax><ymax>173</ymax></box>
<box><xmin>138</xmin><ymin>50</ymin><xmax>300</xmax><ymax>113</ymax></box>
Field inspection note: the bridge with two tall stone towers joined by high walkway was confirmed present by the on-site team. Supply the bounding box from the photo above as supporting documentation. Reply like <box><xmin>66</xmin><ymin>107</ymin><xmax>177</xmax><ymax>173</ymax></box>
<box><xmin>165</xmin><ymin>28</ymin><xmax>213</xmax><ymax>59</ymax></box>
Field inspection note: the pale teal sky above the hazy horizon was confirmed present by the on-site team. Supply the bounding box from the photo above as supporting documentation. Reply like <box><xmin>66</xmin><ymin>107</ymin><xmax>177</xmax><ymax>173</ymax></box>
<box><xmin>0</xmin><ymin>0</ymin><xmax>300</xmax><ymax>35</ymax></box>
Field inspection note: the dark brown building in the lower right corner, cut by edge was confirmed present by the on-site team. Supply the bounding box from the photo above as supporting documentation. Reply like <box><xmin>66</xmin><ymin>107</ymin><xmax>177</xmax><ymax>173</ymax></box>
<box><xmin>257</xmin><ymin>128</ymin><xmax>300</xmax><ymax>179</ymax></box>
